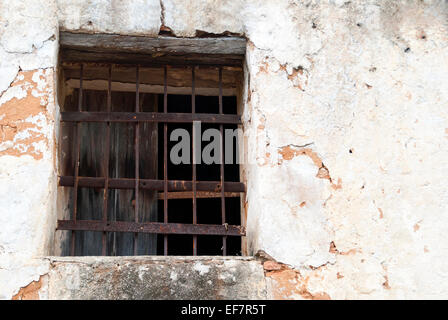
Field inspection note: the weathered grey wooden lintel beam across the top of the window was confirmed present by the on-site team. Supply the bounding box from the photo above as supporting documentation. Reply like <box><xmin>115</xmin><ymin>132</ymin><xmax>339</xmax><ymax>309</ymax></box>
<box><xmin>60</xmin><ymin>31</ymin><xmax>246</xmax><ymax>65</ymax></box>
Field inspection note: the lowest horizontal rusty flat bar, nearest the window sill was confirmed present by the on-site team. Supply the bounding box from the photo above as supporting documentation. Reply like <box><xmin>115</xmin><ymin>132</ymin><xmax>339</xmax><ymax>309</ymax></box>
<box><xmin>56</xmin><ymin>220</ymin><xmax>246</xmax><ymax>236</ymax></box>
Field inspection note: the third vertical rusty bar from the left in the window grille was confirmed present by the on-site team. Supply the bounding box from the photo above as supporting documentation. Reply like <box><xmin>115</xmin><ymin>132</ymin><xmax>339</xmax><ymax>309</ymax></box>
<box><xmin>134</xmin><ymin>66</ymin><xmax>140</xmax><ymax>255</ymax></box>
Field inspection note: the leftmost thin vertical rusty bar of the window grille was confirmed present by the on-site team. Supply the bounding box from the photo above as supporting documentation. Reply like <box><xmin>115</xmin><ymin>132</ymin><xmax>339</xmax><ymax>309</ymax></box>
<box><xmin>70</xmin><ymin>63</ymin><xmax>84</xmax><ymax>256</ymax></box>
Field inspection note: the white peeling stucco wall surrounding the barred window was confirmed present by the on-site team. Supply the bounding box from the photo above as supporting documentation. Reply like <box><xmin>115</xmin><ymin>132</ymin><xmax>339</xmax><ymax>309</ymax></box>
<box><xmin>0</xmin><ymin>0</ymin><xmax>448</xmax><ymax>299</ymax></box>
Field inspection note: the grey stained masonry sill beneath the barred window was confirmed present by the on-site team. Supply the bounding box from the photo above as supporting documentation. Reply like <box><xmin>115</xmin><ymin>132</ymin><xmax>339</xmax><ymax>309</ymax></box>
<box><xmin>46</xmin><ymin>256</ymin><xmax>267</xmax><ymax>300</ymax></box>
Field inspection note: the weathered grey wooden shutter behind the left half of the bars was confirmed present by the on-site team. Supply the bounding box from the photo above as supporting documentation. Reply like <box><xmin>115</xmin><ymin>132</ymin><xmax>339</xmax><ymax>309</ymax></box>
<box><xmin>62</xmin><ymin>90</ymin><xmax>157</xmax><ymax>255</ymax></box>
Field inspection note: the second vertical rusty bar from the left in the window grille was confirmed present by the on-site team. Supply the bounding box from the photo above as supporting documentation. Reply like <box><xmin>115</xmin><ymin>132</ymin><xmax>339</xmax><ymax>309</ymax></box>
<box><xmin>101</xmin><ymin>65</ymin><xmax>112</xmax><ymax>256</ymax></box>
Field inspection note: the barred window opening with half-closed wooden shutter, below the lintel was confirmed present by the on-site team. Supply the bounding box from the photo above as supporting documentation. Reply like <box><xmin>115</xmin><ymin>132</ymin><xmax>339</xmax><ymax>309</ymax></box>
<box><xmin>57</xmin><ymin>62</ymin><xmax>245</xmax><ymax>256</ymax></box>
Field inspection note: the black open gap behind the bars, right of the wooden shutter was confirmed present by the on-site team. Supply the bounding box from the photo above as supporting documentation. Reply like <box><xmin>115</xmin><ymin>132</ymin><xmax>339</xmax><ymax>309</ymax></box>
<box><xmin>157</xmin><ymin>95</ymin><xmax>241</xmax><ymax>255</ymax></box>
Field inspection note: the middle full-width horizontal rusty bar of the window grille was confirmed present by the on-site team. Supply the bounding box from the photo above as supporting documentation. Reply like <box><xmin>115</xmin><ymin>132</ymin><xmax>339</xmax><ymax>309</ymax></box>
<box><xmin>59</xmin><ymin>176</ymin><xmax>246</xmax><ymax>192</ymax></box>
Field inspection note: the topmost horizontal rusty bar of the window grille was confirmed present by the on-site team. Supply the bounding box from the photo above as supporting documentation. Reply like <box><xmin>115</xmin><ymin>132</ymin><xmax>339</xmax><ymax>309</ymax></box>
<box><xmin>61</xmin><ymin>112</ymin><xmax>241</xmax><ymax>124</ymax></box>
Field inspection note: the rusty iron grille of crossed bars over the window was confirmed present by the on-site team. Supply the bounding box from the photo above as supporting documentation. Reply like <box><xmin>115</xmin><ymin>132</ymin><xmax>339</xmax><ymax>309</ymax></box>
<box><xmin>57</xmin><ymin>64</ymin><xmax>245</xmax><ymax>255</ymax></box>
